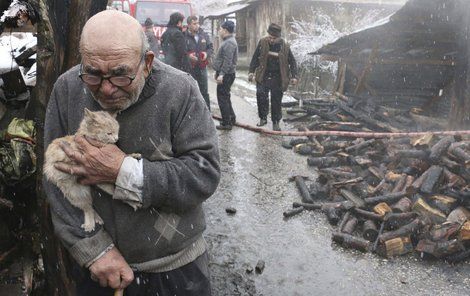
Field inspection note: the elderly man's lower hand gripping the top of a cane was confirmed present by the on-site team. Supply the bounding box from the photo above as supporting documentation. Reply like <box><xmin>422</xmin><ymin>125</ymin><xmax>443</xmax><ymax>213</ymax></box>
<box><xmin>90</xmin><ymin>248</ymin><xmax>134</xmax><ymax>289</ymax></box>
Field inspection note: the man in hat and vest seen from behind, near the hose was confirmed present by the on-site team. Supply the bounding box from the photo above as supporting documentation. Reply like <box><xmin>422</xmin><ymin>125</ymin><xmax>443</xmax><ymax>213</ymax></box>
<box><xmin>248</xmin><ymin>23</ymin><xmax>297</xmax><ymax>131</ymax></box>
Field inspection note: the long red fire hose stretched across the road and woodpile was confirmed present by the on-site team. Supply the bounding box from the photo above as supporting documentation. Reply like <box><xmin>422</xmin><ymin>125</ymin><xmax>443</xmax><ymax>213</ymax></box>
<box><xmin>212</xmin><ymin>115</ymin><xmax>470</xmax><ymax>139</ymax></box>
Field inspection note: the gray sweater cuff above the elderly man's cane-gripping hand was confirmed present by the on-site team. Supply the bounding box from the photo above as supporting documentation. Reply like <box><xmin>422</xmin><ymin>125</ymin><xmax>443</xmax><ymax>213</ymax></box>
<box><xmin>69</xmin><ymin>229</ymin><xmax>113</xmax><ymax>266</ymax></box>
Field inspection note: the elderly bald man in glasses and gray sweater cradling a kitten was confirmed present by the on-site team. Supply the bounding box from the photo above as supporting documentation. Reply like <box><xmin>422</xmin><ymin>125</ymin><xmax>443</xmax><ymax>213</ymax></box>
<box><xmin>44</xmin><ymin>10</ymin><xmax>220</xmax><ymax>296</ymax></box>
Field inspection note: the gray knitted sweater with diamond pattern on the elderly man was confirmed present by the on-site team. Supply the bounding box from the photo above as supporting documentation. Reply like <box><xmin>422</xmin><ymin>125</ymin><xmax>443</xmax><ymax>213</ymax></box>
<box><xmin>44</xmin><ymin>61</ymin><xmax>220</xmax><ymax>272</ymax></box>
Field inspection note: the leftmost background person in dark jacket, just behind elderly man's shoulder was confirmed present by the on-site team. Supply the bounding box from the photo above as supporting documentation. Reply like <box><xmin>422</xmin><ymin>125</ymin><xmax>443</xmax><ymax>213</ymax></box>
<box><xmin>161</xmin><ymin>12</ymin><xmax>190</xmax><ymax>73</ymax></box>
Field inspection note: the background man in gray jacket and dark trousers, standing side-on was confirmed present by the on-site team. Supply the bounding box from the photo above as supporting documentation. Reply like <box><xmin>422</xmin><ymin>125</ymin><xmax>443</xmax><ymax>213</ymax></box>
<box><xmin>213</xmin><ymin>21</ymin><xmax>238</xmax><ymax>130</ymax></box>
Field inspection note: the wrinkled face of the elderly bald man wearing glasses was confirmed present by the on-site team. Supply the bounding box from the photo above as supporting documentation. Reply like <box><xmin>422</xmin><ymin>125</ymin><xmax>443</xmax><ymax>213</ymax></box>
<box><xmin>82</xmin><ymin>50</ymin><xmax>145</xmax><ymax>111</ymax></box>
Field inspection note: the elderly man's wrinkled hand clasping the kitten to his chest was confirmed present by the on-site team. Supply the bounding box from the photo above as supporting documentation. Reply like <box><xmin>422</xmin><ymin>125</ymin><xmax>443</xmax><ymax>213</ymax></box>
<box><xmin>55</xmin><ymin>136</ymin><xmax>126</xmax><ymax>185</ymax></box>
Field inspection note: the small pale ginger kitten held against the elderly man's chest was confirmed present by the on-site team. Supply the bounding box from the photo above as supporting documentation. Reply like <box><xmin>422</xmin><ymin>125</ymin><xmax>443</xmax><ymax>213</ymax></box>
<box><xmin>44</xmin><ymin>108</ymin><xmax>119</xmax><ymax>232</ymax></box>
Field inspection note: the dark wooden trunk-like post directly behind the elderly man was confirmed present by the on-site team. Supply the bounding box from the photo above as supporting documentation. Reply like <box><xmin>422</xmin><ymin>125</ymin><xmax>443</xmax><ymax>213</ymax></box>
<box><xmin>26</xmin><ymin>0</ymin><xmax>107</xmax><ymax>296</ymax></box>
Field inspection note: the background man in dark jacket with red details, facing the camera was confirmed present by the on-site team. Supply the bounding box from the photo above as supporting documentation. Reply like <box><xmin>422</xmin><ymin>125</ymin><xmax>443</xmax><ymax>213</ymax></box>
<box><xmin>184</xmin><ymin>15</ymin><xmax>214</xmax><ymax>110</ymax></box>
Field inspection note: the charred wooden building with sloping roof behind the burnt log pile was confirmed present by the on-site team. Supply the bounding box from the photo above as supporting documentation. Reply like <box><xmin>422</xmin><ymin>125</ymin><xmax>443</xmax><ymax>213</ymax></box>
<box><xmin>314</xmin><ymin>0</ymin><xmax>470</xmax><ymax>127</ymax></box>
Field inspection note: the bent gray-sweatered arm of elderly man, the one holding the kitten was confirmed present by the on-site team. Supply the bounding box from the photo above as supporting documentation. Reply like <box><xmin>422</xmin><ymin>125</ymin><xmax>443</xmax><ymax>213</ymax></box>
<box><xmin>142</xmin><ymin>79</ymin><xmax>220</xmax><ymax>212</ymax></box>
